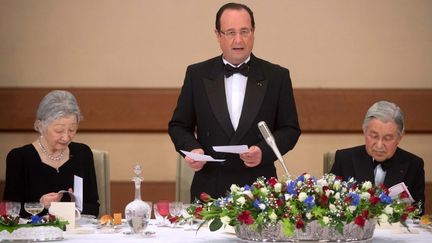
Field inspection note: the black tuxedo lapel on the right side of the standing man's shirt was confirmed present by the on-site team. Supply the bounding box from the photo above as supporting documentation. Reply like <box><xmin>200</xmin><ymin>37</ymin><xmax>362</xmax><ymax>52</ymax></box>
<box><xmin>230</xmin><ymin>55</ymin><xmax>268</xmax><ymax>144</ymax></box>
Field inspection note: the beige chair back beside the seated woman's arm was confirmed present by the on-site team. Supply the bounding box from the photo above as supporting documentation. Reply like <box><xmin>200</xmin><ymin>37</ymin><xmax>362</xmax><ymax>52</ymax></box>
<box><xmin>92</xmin><ymin>149</ymin><xmax>111</xmax><ymax>216</ymax></box>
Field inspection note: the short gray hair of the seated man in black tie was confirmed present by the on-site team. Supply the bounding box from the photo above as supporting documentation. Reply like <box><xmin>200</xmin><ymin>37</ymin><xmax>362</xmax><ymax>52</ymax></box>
<box><xmin>363</xmin><ymin>101</ymin><xmax>405</xmax><ymax>135</ymax></box>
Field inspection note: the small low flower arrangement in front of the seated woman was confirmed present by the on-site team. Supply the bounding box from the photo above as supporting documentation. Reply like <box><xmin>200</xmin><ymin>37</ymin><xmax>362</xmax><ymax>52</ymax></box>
<box><xmin>0</xmin><ymin>214</ymin><xmax>69</xmax><ymax>233</ymax></box>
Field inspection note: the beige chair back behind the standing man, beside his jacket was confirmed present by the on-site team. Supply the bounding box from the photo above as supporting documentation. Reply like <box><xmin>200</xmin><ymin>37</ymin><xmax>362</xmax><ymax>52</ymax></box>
<box><xmin>176</xmin><ymin>155</ymin><xmax>195</xmax><ymax>203</ymax></box>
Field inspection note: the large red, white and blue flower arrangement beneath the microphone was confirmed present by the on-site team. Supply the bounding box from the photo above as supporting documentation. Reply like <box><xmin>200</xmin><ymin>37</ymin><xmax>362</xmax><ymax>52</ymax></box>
<box><xmin>193</xmin><ymin>174</ymin><xmax>420</xmax><ymax>236</ymax></box>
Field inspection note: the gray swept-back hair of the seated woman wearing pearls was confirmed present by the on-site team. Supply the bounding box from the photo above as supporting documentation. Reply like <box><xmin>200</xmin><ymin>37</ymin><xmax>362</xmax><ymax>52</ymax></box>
<box><xmin>34</xmin><ymin>90</ymin><xmax>82</xmax><ymax>132</ymax></box>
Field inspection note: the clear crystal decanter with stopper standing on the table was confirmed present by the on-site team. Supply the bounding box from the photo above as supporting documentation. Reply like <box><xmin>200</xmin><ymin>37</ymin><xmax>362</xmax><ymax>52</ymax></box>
<box><xmin>125</xmin><ymin>164</ymin><xmax>151</xmax><ymax>233</ymax></box>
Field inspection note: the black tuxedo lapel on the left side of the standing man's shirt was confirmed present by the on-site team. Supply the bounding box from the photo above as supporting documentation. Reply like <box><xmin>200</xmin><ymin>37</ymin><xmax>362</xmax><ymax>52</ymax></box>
<box><xmin>203</xmin><ymin>58</ymin><xmax>234</xmax><ymax>137</ymax></box>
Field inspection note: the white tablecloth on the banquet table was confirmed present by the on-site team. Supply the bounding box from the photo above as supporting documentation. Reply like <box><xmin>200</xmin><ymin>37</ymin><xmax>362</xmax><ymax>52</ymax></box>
<box><xmin>60</xmin><ymin>222</ymin><xmax>432</xmax><ymax>243</ymax></box>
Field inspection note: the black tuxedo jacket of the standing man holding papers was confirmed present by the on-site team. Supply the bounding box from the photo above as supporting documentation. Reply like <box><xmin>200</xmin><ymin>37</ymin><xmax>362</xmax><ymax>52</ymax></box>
<box><xmin>168</xmin><ymin>55</ymin><xmax>300</xmax><ymax>200</ymax></box>
